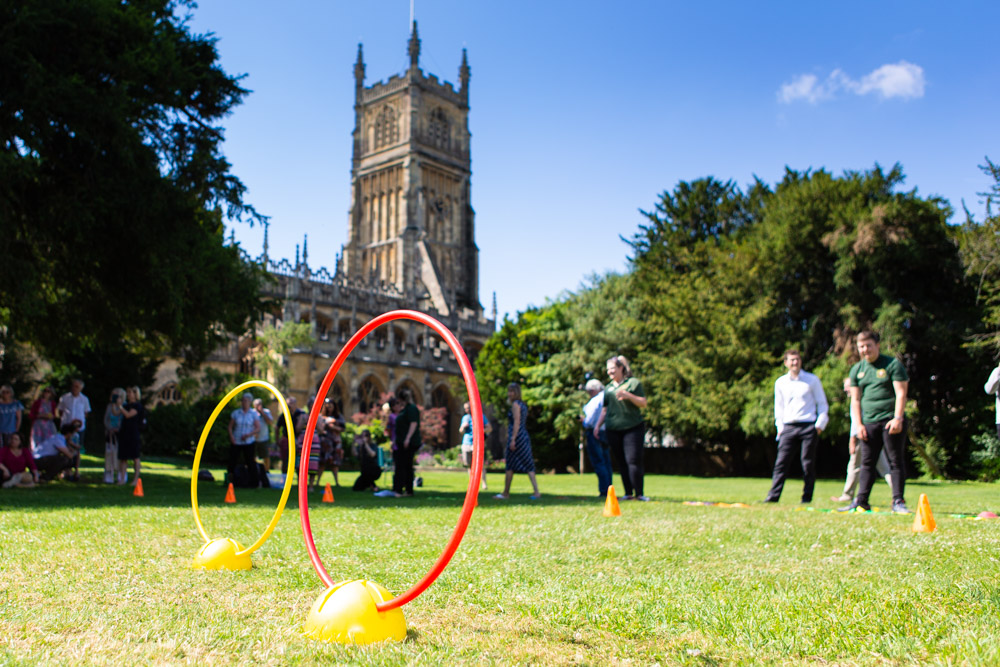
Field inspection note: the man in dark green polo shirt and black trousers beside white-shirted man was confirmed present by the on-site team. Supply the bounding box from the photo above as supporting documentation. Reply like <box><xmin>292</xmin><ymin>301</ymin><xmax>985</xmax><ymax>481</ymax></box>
<box><xmin>839</xmin><ymin>331</ymin><xmax>910</xmax><ymax>514</ymax></box>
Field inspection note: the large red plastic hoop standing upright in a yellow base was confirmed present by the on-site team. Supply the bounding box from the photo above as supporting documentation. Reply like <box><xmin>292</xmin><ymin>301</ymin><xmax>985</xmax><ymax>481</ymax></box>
<box><xmin>299</xmin><ymin>310</ymin><xmax>485</xmax><ymax>611</ymax></box>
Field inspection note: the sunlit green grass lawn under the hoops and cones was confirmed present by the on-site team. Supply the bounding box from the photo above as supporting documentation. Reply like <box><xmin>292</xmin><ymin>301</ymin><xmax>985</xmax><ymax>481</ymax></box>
<box><xmin>0</xmin><ymin>459</ymin><xmax>1000</xmax><ymax>665</ymax></box>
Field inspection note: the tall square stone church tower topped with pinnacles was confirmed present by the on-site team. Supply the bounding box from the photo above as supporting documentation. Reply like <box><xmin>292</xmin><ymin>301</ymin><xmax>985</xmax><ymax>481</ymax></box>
<box><xmin>343</xmin><ymin>21</ymin><xmax>482</xmax><ymax>315</ymax></box>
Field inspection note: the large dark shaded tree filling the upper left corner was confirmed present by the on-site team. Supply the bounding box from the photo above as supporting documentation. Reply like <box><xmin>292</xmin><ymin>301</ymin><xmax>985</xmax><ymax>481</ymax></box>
<box><xmin>0</xmin><ymin>0</ymin><xmax>263</xmax><ymax>364</ymax></box>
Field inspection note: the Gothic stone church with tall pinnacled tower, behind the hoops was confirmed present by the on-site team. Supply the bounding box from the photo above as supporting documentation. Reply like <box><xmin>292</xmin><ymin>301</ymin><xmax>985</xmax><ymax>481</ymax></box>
<box><xmin>155</xmin><ymin>22</ymin><xmax>496</xmax><ymax>444</ymax></box>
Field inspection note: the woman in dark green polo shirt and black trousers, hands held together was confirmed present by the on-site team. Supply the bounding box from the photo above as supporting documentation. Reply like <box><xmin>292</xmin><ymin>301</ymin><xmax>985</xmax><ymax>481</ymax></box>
<box><xmin>594</xmin><ymin>355</ymin><xmax>649</xmax><ymax>500</ymax></box>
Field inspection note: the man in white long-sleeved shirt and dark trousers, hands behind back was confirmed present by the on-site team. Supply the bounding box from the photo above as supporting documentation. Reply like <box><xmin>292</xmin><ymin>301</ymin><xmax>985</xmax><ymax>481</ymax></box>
<box><xmin>764</xmin><ymin>350</ymin><xmax>830</xmax><ymax>503</ymax></box>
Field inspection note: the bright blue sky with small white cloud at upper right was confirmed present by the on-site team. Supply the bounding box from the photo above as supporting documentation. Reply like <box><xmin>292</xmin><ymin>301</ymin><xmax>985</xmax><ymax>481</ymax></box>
<box><xmin>192</xmin><ymin>0</ymin><xmax>1000</xmax><ymax>316</ymax></box>
